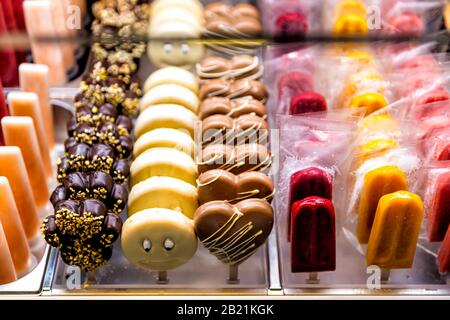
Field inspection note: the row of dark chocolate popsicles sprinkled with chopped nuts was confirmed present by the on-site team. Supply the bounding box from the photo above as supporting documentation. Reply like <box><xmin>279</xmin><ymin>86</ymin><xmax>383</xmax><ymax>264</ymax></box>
<box><xmin>41</xmin><ymin>1</ymin><xmax>146</xmax><ymax>271</ymax></box>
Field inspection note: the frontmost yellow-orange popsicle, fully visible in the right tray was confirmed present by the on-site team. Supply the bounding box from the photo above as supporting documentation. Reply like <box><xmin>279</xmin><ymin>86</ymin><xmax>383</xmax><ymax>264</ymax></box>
<box><xmin>366</xmin><ymin>191</ymin><xmax>423</xmax><ymax>269</ymax></box>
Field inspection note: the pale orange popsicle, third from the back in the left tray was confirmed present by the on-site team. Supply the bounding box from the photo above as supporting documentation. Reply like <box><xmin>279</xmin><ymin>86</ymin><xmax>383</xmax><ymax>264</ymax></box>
<box><xmin>1</xmin><ymin>117</ymin><xmax>49</xmax><ymax>207</ymax></box>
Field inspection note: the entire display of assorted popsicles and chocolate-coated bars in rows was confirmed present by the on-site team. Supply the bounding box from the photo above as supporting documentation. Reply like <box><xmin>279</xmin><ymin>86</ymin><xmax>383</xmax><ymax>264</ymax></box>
<box><xmin>0</xmin><ymin>0</ymin><xmax>450</xmax><ymax>294</ymax></box>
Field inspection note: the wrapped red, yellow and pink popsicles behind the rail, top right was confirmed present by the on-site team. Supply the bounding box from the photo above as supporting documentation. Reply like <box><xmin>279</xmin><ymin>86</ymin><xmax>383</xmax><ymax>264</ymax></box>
<box><xmin>259</xmin><ymin>0</ymin><xmax>442</xmax><ymax>39</ymax></box>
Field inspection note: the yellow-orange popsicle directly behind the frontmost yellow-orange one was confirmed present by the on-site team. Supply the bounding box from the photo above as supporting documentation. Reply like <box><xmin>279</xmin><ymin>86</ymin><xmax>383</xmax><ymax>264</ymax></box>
<box><xmin>357</xmin><ymin>166</ymin><xmax>408</xmax><ymax>244</ymax></box>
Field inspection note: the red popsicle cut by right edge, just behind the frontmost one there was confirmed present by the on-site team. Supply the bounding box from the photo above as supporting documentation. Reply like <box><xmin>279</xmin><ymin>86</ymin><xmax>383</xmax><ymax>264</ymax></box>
<box><xmin>427</xmin><ymin>172</ymin><xmax>450</xmax><ymax>242</ymax></box>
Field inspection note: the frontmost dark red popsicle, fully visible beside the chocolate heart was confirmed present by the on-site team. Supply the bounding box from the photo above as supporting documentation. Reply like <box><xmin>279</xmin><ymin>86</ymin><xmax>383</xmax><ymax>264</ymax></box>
<box><xmin>291</xmin><ymin>197</ymin><xmax>336</xmax><ymax>272</ymax></box>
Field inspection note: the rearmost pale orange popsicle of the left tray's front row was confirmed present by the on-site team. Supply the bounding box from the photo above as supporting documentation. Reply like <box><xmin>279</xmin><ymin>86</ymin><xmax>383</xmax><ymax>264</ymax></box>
<box><xmin>19</xmin><ymin>63</ymin><xmax>55</xmax><ymax>149</ymax></box>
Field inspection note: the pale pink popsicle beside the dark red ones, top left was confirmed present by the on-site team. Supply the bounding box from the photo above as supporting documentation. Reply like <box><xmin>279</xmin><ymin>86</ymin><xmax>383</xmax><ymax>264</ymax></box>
<box><xmin>23</xmin><ymin>0</ymin><xmax>67</xmax><ymax>85</ymax></box>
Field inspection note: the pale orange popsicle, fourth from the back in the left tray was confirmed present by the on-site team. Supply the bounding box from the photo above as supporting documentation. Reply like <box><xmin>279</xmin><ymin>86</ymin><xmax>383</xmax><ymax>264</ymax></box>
<box><xmin>0</xmin><ymin>147</ymin><xmax>40</xmax><ymax>240</ymax></box>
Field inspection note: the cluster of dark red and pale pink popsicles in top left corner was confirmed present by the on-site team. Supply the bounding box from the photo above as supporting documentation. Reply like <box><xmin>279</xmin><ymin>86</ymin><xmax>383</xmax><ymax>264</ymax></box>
<box><xmin>0</xmin><ymin>0</ymin><xmax>86</xmax><ymax>87</ymax></box>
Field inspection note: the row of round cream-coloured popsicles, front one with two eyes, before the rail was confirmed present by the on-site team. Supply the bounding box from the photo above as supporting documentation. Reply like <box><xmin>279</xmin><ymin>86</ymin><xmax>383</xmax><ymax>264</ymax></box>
<box><xmin>121</xmin><ymin>65</ymin><xmax>199</xmax><ymax>283</ymax></box>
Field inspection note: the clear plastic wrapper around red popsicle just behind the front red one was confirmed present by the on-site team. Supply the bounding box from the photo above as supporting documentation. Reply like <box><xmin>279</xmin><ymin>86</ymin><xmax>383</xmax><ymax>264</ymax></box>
<box><xmin>276</xmin><ymin>113</ymin><xmax>356</xmax><ymax>235</ymax></box>
